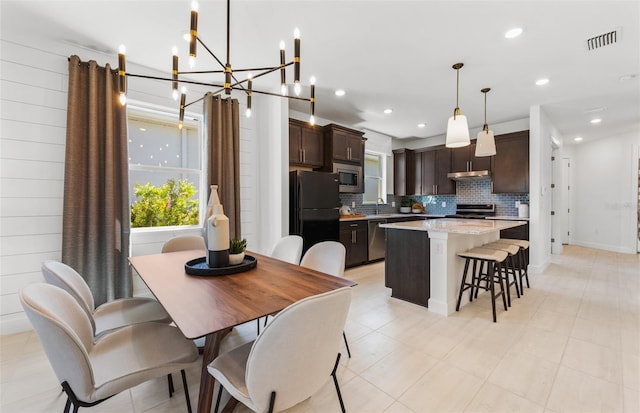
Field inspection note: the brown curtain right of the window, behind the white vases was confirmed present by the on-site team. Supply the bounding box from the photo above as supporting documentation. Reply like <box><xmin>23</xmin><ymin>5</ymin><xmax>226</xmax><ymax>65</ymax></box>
<box><xmin>204</xmin><ymin>93</ymin><xmax>242</xmax><ymax>238</ymax></box>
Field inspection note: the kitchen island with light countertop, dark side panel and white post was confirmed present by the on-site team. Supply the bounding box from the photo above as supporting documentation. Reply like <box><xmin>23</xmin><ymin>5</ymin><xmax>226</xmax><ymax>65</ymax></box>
<box><xmin>380</xmin><ymin>218</ymin><xmax>526</xmax><ymax>315</ymax></box>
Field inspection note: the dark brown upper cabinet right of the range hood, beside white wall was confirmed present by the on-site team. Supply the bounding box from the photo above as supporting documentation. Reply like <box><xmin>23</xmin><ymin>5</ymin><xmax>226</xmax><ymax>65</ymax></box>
<box><xmin>493</xmin><ymin>130</ymin><xmax>529</xmax><ymax>194</ymax></box>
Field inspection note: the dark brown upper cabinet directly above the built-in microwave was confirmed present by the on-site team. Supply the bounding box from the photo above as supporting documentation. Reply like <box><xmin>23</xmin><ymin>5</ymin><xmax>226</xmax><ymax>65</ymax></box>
<box><xmin>323</xmin><ymin>123</ymin><xmax>365</xmax><ymax>166</ymax></box>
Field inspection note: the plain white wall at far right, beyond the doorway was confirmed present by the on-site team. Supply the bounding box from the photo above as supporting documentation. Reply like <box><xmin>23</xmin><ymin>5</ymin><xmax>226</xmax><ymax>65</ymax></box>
<box><xmin>563</xmin><ymin>128</ymin><xmax>640</xmax><ymax>253</ymax></box>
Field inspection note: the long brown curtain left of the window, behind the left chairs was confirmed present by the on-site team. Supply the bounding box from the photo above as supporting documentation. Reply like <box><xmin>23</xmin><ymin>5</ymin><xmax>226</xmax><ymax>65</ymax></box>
<box><xmin>62</xmin><ymin>56</ymin><xmax>133</xmax><ymax>305</ymax></box>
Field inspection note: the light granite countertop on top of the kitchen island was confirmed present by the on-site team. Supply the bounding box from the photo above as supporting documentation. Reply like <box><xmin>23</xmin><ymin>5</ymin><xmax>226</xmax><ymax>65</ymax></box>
<box><xmin>380</xmin><ymin>218</ymin><xmax>525</xmax><ymax>235</ymax></box>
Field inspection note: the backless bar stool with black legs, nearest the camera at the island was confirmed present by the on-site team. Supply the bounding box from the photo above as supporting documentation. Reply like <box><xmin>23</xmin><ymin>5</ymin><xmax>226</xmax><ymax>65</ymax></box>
<box><xmin>456</xmin><ymin>248</ymin><xmax>508</xmax><ymax>323</ymax></box>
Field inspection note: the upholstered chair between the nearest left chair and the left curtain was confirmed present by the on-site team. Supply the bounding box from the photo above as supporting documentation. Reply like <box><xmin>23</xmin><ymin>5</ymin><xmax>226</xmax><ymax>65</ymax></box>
<box><xmin>42</xmin><ymin>260</ymin><xmax>171</xmax><ymax>337</ymax></box>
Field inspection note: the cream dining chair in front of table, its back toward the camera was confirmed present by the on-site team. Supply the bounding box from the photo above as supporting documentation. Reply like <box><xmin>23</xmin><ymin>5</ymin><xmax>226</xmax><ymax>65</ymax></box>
<box><xmin>207</xmin><ymin>287</ymin><xmax>351</xmax><ymax>413</ymax></box>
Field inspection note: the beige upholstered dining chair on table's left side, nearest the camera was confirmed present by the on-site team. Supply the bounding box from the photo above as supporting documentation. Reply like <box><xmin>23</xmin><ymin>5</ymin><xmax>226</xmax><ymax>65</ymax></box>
<box><xmin>19</xmin><ymin>283</ymin><xmax>199</xmax><ymax>413</ymax></box>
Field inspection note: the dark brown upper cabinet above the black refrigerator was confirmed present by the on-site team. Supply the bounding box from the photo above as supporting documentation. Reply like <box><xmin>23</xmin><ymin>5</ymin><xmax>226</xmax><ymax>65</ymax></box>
<box><xmin>289</xmin><ymin>119</ymin><xmax>324</xmax><ymax>168</ymax></box>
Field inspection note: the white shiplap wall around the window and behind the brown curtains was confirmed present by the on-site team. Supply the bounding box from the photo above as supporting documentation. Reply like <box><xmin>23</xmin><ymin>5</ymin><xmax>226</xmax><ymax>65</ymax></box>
<box><xmin>0</xmin><ymin>30</ymin><xmax>288</xmax><ymax>334</ymax></box>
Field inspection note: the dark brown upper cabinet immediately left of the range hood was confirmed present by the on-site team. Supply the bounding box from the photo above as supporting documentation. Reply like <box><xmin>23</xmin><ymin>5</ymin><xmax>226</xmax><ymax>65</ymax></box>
<box><xmin>420</xmin><ymin>147</ymin><xmax>456</xmax><ymax>195</ymax></box>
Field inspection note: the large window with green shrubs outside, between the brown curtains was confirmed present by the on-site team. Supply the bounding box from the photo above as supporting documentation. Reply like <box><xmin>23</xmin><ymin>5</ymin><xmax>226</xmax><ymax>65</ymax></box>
<box><xmin>127</xmin><ymin>105</ymin><xmax>204</xmax><ymax>228</ymax></box>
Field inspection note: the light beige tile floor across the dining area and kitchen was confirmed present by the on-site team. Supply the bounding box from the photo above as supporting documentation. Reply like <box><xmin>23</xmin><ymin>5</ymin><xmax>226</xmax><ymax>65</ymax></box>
<box><xmin>0</xmin><ymin>246</ymin><xmax>640</xmax><ymax>413</ymax></box>
